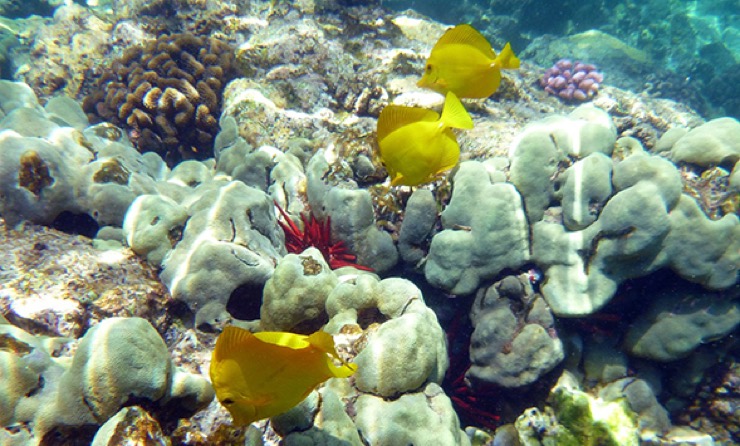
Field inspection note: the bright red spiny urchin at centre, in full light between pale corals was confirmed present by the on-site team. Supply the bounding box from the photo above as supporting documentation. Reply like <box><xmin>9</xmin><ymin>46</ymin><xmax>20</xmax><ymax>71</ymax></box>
<box><xmin>275</xmin><ymin>203</ymin><xmax>373</xmax><ymax>271</ymax></box>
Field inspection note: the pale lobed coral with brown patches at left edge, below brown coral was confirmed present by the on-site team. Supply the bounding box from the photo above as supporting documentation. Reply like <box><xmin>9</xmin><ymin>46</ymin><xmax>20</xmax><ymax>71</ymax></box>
<box><xmin>0</xmin><ymin>81</ymin><xmax>169</xmax><ymax>228</ymax></box>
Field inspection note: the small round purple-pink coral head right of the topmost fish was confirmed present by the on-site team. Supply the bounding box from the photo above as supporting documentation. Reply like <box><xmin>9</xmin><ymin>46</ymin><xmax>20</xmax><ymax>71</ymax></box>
<box><xmin>540</xmin><ymin>59</ymin><xmax>604</xmax><ymax>102</ymax></box>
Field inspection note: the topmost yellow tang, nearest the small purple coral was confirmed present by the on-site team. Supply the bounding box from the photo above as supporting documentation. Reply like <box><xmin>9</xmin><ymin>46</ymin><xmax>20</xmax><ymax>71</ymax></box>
<box><xmin>417</xmin><ymin>24</ymin><xmax>519</xmax><ymax>98</ymax></box>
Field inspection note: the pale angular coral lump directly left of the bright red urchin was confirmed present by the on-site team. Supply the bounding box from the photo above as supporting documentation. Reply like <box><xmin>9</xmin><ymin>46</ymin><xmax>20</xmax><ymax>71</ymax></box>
<box><xmin>161</xmin><ymin>181</ymin><xmax>284</xmax><ymax>313</ymax></box>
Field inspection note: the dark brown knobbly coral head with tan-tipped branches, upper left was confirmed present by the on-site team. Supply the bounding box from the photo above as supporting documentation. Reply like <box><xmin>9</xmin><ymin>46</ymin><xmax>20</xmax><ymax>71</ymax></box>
<box><xmin>83</xmin><ymin>34</ymin><xmax>234</xmax><ymax>165</ymax></box>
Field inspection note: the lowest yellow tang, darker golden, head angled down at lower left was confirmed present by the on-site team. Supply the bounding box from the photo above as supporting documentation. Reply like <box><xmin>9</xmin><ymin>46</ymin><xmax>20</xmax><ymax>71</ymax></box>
<box><xmin>211</xmin><ymin>326</ymin><xmax>357</xmax><ymax>425</ymax></box>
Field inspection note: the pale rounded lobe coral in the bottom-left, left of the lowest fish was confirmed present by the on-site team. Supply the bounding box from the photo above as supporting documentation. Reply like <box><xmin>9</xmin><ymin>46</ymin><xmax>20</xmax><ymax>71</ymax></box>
<box><xmin>0</xmin><ymin>317</ymin><xmax>214</xmax><ymax>442</ymax></box>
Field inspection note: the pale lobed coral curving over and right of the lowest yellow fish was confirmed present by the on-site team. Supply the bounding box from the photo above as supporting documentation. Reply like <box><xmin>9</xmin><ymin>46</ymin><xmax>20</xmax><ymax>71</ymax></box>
<box><xmin>253</xmin><ymin>248</ymin><xmax>462</xmax><ymax>445</ymax></box>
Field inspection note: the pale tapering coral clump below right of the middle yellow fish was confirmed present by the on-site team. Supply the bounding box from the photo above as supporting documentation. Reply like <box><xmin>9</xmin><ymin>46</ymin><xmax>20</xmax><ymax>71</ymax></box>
<box><xmin>424</xmin><ymin>161</ymin><xmax>529</xmax><ymax>294</ymax></box>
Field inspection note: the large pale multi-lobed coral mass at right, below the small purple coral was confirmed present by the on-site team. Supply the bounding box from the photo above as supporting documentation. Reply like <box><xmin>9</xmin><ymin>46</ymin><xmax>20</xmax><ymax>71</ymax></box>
<box><xmin>500</xmin><ymin>106</ymin><xmax>740</xmax><ymax>316</ymax></box>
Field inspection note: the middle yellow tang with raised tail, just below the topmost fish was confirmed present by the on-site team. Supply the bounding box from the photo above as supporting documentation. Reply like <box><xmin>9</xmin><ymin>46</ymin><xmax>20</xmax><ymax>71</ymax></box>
<box><xmin>378</xmin><ymin>92</ymin><xmax>473</xmax><ymax>186</ymax></box>
